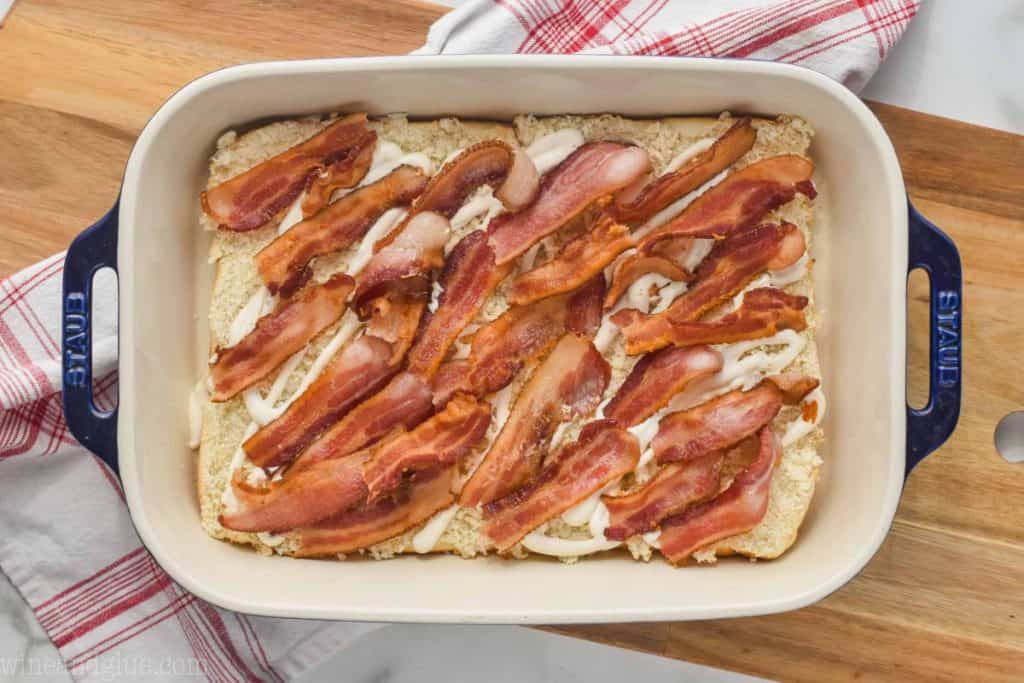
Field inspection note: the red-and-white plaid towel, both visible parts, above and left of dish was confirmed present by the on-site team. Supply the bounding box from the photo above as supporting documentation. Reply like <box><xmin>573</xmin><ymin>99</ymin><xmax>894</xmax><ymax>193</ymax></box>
<box><xmin>0</xmin><ymin>0</ymin><xmax>918</xmax><ymax>681</ymax></box>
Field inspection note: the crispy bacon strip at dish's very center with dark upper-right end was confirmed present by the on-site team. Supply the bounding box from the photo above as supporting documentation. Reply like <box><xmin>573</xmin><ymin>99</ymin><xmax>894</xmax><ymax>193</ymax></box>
<box><xmin>434</xmin><ymin>274</ymin><xmax>604</xmax><ymax>404</ymax></box>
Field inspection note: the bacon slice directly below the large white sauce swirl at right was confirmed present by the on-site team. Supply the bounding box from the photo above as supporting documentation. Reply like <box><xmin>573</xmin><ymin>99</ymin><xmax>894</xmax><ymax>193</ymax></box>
<box><xmin>651</xmin><ymin>382</ymin><xmax>782</xmax><ymax>463</ymax></box>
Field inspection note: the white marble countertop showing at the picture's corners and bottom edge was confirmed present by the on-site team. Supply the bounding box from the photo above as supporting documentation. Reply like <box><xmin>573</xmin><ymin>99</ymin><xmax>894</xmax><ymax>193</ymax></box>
<box><xmin>0</xmin><ymin>0</ymin><xmax>1024</xmax><ymax>683</ymax></box>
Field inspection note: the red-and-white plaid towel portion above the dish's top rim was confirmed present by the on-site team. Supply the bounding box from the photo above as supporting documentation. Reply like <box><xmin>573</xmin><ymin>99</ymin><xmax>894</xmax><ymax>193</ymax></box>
<box><xmin>414</xmin><ymin>0</ymin><xmax>920</xmax><ymax>92</ymax></box>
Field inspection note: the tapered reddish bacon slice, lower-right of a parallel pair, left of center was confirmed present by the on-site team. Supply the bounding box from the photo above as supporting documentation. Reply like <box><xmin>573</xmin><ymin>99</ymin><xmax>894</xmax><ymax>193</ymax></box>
<box><xmin>292</xmin><ymin>373</ymin><xmax>433</xmax><ymax>469</ymax></box>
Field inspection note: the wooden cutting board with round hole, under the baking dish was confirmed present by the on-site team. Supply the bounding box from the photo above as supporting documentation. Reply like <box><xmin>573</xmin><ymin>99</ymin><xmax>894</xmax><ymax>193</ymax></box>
<box><xmin>0</xmin><ymin>0</ymin><xmax>1024</xmax><ymax>682</ymax></box>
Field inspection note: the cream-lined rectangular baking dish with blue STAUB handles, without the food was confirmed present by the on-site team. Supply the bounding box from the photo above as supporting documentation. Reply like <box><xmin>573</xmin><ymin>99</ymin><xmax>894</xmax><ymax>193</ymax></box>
<box><xmin>63</xmin><ymin>55</ymin><xmax>962</xmax><ymax>624</ymax></box>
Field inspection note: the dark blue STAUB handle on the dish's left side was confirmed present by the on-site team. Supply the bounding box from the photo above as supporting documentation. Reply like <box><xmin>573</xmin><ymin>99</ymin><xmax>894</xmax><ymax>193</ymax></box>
<box><xmin>60</xmin><ymin>204</ymin><xmax>119</xmax><ymax>474</ymax></box>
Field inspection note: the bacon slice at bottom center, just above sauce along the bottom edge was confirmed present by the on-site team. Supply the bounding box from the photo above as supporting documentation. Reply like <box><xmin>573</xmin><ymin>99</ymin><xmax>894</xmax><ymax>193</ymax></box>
<box><xmin>483</xmin><ymin>420</ymin><xmax>640</xmax><ymax>552</ymax></box>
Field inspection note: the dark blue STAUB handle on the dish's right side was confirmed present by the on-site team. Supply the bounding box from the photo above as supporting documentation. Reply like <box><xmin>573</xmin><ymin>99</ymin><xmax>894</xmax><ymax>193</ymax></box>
<box><xmin>906</xmin><ymin>203</ymin><xmax>964</xmax><ymax>474</ymax></box>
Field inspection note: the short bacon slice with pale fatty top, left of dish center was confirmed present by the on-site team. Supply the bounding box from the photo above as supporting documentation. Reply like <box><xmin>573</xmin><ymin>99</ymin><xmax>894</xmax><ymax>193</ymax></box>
<box><xmin>352</xmin><ymin>211</ymin><xmax>449</xmax><ymax>318</ymax></box>
